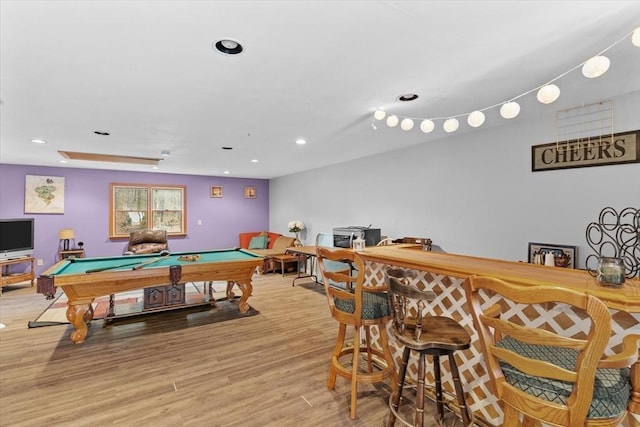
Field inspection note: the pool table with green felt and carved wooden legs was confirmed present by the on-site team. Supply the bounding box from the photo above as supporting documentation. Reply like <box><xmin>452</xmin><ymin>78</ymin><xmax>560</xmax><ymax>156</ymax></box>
<box><xmin>37</xmin><ymin>248</ymin><xmax>264</xmax><ymax>344</ymax></box>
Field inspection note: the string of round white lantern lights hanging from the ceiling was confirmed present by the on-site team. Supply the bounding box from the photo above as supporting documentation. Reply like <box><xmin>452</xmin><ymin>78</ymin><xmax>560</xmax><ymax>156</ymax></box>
<box><xmin>372</xmin><ymin>27</ymin><xmax>640</xmax><ymax>133</ymax></box>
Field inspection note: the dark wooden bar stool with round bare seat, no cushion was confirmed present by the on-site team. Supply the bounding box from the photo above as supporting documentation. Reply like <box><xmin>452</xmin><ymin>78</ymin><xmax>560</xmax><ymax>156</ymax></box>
<box><xmin>386</xmin><ymin>268</ymin><xmax>472</xmax><ymax>427</ymax></box>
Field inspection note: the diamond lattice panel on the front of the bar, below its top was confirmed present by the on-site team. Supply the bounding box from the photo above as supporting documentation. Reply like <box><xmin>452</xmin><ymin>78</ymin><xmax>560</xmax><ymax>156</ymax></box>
<box><xmin>365</xmin><ymin>261</ymin><xmax>640</xmax><ymax>426</ymax></box>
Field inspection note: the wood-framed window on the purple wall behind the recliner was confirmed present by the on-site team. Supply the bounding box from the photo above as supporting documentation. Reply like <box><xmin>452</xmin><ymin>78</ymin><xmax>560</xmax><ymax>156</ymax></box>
<box><xmin>109</xmin><ymin>184</ymin><xmax>187</xmax><ymax>238</ymax></box>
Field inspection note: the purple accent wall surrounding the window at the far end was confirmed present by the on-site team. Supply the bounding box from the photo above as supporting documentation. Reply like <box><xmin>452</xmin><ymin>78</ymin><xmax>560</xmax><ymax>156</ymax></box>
<box><xmin>0</xmin><ymin>164</ymin><xmax>269</xmax><ymax>274</ymax></box>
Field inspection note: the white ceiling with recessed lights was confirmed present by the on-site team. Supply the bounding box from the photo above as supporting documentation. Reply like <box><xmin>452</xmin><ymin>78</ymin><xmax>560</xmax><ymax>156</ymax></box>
<box><xmin>0</xmin><ymin>0</ymin><xmax>640</xmax><ymax>178</ymax></box>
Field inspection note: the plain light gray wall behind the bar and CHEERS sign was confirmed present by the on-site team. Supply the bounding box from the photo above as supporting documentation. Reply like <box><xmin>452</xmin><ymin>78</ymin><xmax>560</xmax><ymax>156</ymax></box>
<box><xmin>270</xmin><ymin>92</ymin><xmax>640</xmax><ymax>268</ymax></box>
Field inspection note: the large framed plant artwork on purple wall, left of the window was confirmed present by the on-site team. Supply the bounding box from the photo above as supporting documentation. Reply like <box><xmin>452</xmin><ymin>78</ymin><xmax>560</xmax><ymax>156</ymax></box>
<box><xmin>24</xmin><ymin>175</ymin><xmax>64</xmax><ymax>214</ymax></box>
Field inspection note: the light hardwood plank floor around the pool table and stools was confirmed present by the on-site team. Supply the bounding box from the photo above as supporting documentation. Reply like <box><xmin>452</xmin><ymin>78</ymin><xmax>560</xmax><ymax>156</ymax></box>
<box><xmin>0</xmin><ymin>274</ymin><xmax>460</xmax><ymax>427</ymax></box>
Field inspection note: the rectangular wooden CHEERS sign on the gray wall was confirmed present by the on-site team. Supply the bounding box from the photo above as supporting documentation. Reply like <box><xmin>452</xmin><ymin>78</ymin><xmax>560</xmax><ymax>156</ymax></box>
<box><xmin>531</xmin><ymin>131</ymin><xmax>640</xmax><ymax>172</ymax></box>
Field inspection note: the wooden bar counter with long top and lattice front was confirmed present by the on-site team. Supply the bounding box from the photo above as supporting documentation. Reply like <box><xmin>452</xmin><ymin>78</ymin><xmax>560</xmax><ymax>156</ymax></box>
<box><xmin>358</xmin><ymin>245</ymin><xmax>640</xmax><ymax>426</ymax></box>
